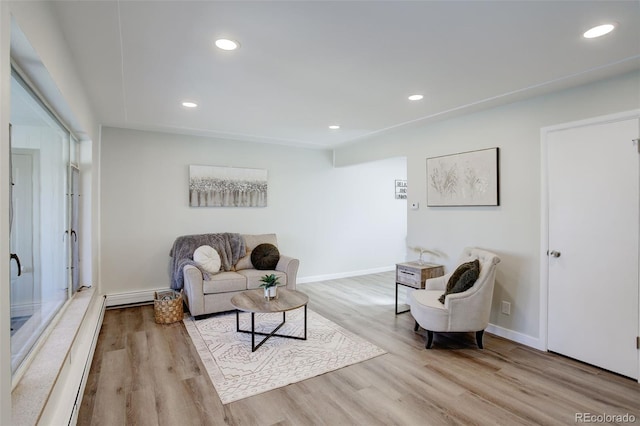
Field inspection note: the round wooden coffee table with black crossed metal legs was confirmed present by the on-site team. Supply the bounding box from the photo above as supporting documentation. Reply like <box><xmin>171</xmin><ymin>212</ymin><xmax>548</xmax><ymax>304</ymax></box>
<box><xmin>231</xmin><ymin>288</ymin><xmax>309</xmax><ymax>352</ymax></box>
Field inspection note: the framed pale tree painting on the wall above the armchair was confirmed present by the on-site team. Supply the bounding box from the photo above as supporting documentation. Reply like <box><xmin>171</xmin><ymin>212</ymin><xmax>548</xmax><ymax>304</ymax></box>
<box><xmin>427</xmin><ymin>148</ymin><xmax>500</xmax><ymax>207</ymax></box>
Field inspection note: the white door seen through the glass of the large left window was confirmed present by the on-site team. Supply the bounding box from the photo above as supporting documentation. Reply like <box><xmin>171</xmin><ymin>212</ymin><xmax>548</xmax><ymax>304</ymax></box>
<box><xmin>10</xmin><ymin>153</ymin><xmax>36</xmax><ymax>318</ymax></box>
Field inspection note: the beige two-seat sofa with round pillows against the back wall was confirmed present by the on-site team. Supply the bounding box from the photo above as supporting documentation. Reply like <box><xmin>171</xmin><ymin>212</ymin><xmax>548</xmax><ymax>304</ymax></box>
<box><xmin>171</xmin><ymin>234</ymin><xmax>300</xmax><ymax>319</ymax></box>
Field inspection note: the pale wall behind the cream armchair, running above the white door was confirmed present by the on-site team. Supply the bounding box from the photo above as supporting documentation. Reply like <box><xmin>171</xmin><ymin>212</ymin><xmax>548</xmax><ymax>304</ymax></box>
<box><xmin>336</xmin><ymin>73</ymin><xmax>640</xmax><ymax>345</ymax></box>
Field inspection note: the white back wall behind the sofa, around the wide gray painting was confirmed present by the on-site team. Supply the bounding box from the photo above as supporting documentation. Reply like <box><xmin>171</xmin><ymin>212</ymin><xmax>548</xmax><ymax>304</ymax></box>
<box><xmin>100</xmin><ymin>128</ymin><xmax>406</xmax><ymax>294</ymax></box>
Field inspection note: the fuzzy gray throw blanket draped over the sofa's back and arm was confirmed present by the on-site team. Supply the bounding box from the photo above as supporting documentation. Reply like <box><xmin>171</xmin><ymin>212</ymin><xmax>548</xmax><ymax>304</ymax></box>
<box><xmin>169</xmin><ymin>233</ymin><xmax>246</xmax><ymax>290</ymax></box>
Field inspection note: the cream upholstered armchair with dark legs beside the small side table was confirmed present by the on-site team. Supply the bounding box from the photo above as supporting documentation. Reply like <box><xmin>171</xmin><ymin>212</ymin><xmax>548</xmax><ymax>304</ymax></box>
<box><xmin>409</xmin><ymin>247</ymin><xmax>500</xmax><ymax>349</ymax></box>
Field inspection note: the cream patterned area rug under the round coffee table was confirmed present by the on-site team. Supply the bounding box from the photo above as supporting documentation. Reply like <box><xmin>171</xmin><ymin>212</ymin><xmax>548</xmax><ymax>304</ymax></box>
<box><xmin>184</xmin><ymin>309</ymin><xmax>385</xmax><ymax>404</ymax></box>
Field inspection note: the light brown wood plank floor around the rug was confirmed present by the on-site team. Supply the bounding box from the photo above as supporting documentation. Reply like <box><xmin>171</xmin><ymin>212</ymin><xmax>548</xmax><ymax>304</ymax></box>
<box><xmin>78</xmin><ymin>272</ymin><xmax>640</xmax><ymax>425</ymax></box>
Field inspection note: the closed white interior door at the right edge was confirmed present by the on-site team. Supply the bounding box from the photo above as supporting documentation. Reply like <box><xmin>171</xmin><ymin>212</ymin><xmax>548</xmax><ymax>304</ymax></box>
<box><xmin>547</xmin><ymin>119</ymin><xmax>640</xmax><ymax>379</ymax></box>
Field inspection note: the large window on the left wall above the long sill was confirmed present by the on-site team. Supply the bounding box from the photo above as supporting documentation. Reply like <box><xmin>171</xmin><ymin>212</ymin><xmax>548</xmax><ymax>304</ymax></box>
<box><xmin>10</xmin><ymin>70</ymin><xmax>72</xmax><ymax>374</ymax></box>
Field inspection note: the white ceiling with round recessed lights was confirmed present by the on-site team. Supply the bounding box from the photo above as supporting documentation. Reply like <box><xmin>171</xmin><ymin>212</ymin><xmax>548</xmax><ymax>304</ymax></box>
<box><xmin>54</xmin><ymin>0</ymin><xmax>640</xmax><ymax>148</ymax></box>
